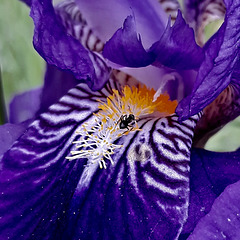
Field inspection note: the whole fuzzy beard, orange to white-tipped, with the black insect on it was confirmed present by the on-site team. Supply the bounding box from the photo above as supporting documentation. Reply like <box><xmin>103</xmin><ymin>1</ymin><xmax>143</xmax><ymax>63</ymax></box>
<box><xmin>67</xmin><ymin>85</ymin><xmax>177</xmax><ymax>168</ymax></box>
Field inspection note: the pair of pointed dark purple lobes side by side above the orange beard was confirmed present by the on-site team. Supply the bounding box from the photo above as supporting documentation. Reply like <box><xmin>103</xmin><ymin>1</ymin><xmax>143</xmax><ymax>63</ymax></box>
<box><xmin>103</xmin><ymin>11</ymin><xmax>204</xmax><ymax>70</ymax></box>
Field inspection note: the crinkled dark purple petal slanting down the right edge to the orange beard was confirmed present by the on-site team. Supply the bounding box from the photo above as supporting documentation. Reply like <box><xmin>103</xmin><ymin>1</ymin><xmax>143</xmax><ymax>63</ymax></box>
<box><xmin>176</xmin><ymin>0</ymin><xmax>240</xmax><ymax>119</ymax></box>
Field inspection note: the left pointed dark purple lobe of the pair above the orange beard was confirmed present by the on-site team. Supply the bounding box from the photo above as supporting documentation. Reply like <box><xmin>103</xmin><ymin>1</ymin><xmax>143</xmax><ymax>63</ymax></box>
<box><xmin>103</xmin><ymin>16</ymin><xmax>154</xmax><ymax>67</ymax></box>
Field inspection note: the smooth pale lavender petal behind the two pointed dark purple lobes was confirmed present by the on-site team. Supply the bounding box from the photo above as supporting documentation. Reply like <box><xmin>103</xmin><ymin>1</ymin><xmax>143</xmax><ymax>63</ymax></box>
<box><xmin>76</xmin><ymin>0</ymin><xmax>167</xmax><ymax>47</ymax></box>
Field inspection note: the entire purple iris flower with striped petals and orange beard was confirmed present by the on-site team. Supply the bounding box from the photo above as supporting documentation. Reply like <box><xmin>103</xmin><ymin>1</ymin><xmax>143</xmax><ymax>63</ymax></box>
<box><xmin>0</xmin><ymin>0</ymin><xmax>240</xmax><ymax>240</ymax></box>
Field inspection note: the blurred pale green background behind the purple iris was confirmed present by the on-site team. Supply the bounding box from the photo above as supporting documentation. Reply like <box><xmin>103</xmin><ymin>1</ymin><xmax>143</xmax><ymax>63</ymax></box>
<box><xmin>0</xmin><ymin>0</ymin><xmax>240</xmax><ymax>151</ymax></box>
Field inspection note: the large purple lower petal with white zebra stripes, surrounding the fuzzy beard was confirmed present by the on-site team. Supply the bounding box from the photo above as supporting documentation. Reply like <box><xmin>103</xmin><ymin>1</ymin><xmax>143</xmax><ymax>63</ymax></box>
<box><xmin>0</xmin><ymin>78</ymin><xmax>198</xmax><ymax>240</ymax></box>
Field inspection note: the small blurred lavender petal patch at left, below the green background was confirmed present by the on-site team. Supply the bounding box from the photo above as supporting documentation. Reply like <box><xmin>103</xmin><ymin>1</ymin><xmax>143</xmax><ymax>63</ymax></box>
<box><xmin>9</xmin><ymin>88</ymin><xmax>42</xmax><ymax>123</ymax></box>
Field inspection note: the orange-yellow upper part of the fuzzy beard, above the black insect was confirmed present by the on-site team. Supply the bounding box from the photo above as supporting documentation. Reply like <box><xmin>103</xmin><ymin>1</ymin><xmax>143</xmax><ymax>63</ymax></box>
<box><xmin>98</xmin><ymin>85</ymin><xmax>177</xmax><ymax>120</ymax></box>
